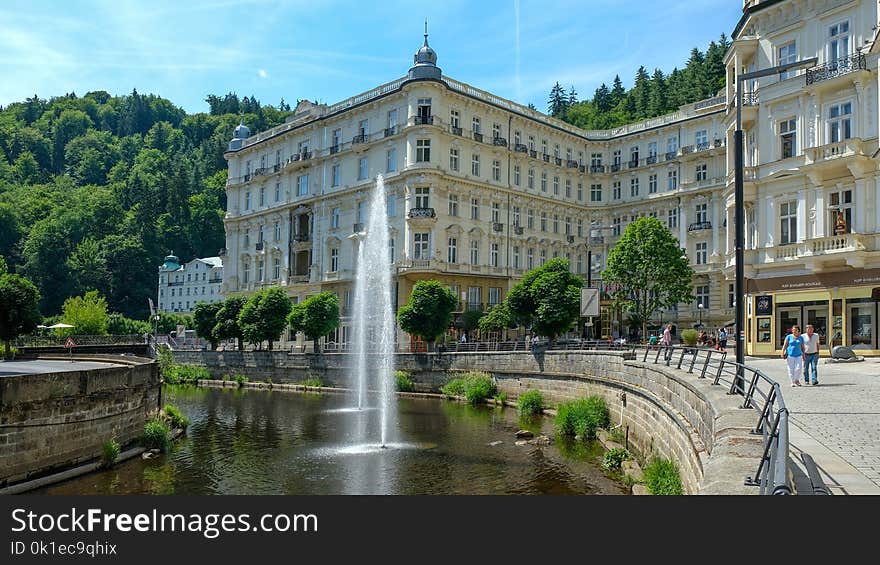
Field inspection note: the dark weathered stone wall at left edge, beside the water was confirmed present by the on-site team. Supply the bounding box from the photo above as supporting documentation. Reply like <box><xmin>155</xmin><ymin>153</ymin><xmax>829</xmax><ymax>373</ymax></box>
<box><xmin>0</xmin><ymin>356</ymin><xmax>161</xmax><ymax>486</ymax></box>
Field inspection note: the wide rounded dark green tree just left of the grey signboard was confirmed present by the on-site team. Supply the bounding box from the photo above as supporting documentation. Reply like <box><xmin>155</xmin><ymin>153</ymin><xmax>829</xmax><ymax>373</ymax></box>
<box><xmin>507</xmin><ymin>258</ymin><xmax>583</xmax><ymax>342</ymax></box>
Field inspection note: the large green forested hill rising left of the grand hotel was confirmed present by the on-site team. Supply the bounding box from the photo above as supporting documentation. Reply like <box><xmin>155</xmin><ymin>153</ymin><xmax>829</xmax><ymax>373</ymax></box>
<box><xmin>0</xmin><ymin>91</ymin><xmax>290</xmax><ymax>319</ymax></box>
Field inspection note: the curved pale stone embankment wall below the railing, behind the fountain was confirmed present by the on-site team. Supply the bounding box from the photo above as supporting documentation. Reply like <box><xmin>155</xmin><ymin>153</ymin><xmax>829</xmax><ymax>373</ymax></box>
<box><xmin>174</xmin><ymin>351</ymin><xmax>762</xmax><ymax>494</ymax></box>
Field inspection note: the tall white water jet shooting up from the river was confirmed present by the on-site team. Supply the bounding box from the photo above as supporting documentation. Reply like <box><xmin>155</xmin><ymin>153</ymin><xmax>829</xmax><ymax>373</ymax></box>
<box><xmin>354</xmin><ymin>175</ymin><xmax>396</xmax><ymax>449</ymax></box>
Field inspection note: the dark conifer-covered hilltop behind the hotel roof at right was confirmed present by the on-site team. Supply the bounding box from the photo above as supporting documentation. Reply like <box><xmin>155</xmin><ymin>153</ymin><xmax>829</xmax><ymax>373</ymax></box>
<box><xmin>547</xmin><ymin>34</ymin><xmax>730</xmax><ymax>129</ymax></box>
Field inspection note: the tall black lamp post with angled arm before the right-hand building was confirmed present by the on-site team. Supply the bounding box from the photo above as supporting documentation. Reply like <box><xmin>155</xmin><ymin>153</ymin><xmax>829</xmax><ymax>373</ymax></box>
<box><xmin>731</xmin><ymin>57</ymin><xmax>819</xmax><ymax>392</ymax></box>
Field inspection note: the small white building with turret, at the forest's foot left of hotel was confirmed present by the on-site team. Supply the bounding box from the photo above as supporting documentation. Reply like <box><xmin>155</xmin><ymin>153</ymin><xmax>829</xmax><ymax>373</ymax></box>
<box><xmin>157</xmin><ymin>253</ymin><xmax>223</xmax><ymax>314</ymax></box>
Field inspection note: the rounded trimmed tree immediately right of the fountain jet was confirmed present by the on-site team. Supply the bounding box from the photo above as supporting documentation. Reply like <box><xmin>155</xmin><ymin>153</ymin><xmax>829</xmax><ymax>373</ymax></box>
<box><xmin>397</xmin><ymin>280</ymin><xmax>458</xmax><ymax>344</ymax></box>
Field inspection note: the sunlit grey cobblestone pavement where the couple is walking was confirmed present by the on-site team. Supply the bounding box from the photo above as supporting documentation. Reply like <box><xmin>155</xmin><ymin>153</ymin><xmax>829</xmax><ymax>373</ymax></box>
<box><xmin>746</xmin><ymin>357</ymin><xmax>880</xmax><ymax>494</ymax></box>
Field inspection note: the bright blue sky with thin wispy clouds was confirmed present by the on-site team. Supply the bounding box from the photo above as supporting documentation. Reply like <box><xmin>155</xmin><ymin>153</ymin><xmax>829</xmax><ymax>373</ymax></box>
<box><xmin>0</xmin><ymin>0</ymin><xmax>742</xmax><ymax>112</ymax></box>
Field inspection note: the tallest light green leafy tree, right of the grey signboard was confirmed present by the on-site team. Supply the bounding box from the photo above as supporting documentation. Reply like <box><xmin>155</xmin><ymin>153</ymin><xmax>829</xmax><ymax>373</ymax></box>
<box><xmin>602</xmin><ymin>216</ymin><xmax>694</xmax><ymax>336</ymax></box>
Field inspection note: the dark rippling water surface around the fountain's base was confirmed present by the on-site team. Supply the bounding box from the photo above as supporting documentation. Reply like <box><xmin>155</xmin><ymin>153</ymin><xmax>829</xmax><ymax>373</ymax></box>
<box><xmin>36</xmin><ymin>387</ymin><xmax>628</xmax><ymax>494</ymax></box>
